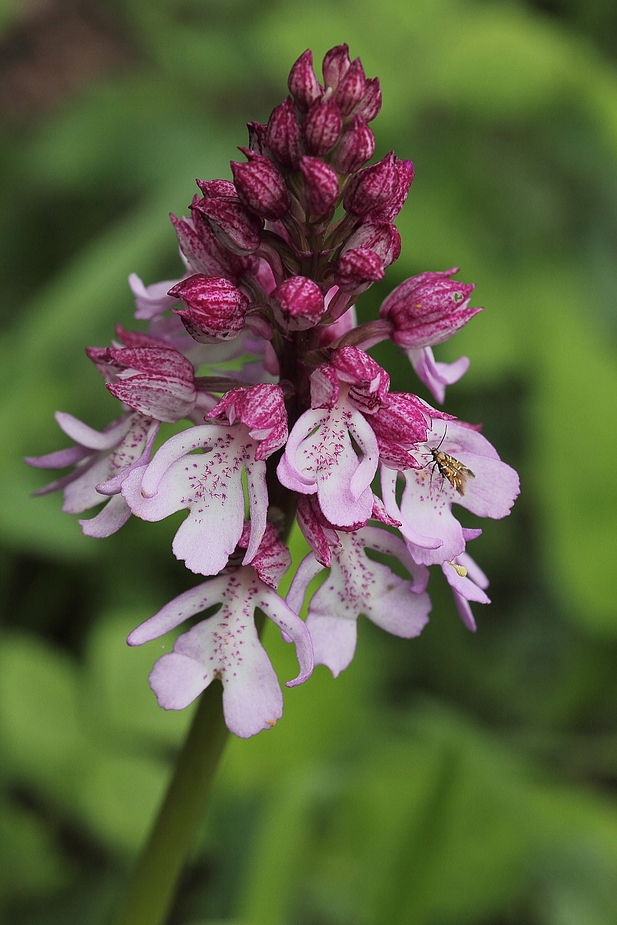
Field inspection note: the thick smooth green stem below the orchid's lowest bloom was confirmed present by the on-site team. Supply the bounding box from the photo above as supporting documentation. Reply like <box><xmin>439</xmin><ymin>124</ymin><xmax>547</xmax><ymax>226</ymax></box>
<box><xmin>116</xmin><ymin>683</ymin><xmax>227</xmax><ymax>925</ymax></box>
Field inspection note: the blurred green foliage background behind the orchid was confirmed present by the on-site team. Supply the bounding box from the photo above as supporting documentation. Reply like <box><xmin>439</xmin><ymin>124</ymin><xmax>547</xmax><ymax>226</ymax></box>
<box><xmin>0</xmin><ymin>0</ymin><xmax>617</xmax><ymax>925</ymax></box>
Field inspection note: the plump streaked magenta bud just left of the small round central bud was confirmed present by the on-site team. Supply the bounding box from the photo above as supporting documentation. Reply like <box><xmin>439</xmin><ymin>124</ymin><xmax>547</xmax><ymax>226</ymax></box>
<box><xmin>169</xmin><ymin>273</ymin><xmax>249</xmax><ymax>344</ymax></box>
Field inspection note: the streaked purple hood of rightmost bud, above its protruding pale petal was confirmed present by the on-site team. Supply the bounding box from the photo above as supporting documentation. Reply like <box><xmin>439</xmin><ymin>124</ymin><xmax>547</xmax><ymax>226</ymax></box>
<box><xmin>379</xmin><ymin>267</ymin><xmax>482</xmax><ymax>348</ymax></box>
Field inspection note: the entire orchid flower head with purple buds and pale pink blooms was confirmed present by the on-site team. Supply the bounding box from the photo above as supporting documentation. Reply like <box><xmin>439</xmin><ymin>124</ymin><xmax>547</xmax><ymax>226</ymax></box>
<box><xmin>28</xmin><ymin>45</ymin><xmax>518</xmax><ymax>736</ymax></box>
